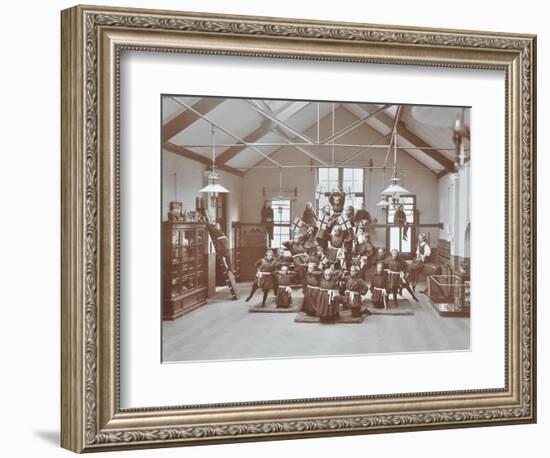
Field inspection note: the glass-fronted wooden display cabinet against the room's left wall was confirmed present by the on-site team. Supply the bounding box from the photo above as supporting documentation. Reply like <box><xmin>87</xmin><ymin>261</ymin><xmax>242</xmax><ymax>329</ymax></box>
<box><xmin>162</xmin><ymin>221</ymin><xmax>208</xmax><ymax>320</ymax></box>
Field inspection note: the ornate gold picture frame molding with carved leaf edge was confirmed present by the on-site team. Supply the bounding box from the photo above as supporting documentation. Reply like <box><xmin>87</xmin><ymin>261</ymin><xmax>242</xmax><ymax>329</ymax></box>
<box><xmin>61</xmin><ymin>6</ymin><xmax>536</xmax><ymax>452</ymax></box>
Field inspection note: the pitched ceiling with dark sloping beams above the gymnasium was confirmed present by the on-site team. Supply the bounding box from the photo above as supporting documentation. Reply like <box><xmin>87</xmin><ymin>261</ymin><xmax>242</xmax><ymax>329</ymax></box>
<box><xmin>162</xmin><ymin>96</ymin><xmax>469</xmax><ymax>174</ymax></box>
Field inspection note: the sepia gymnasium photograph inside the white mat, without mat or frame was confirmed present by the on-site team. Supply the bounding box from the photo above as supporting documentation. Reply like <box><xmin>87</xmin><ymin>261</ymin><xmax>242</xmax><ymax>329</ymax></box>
<box><xmin>161</xmin><ymin>94</ymin><xmax>470</xmax><ymax>362</ymax></box>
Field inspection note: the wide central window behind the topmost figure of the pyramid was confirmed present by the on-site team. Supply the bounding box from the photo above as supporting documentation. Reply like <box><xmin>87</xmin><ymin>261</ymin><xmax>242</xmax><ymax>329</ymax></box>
<box><xmin>317</xmin><ymin>167</ymin><xmax>365</xmax><ymax>211</ymax></box>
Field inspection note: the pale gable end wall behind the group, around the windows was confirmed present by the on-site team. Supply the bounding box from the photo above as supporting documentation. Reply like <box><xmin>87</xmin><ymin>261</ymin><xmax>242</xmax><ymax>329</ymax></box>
<box><xmin>242</xmin><ymin>108</ymin><xmax>439</xmax><ymax>246</ymax></box>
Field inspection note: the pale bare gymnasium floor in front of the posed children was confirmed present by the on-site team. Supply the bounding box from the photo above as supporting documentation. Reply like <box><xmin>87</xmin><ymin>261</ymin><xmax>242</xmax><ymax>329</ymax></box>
<box><xmin>162</xmin><ymin>283</ymin><xmax>470</xmax><ymax>362</ymax></box>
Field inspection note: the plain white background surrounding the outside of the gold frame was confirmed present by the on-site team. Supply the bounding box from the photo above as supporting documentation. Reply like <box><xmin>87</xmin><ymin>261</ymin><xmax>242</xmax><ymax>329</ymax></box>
<box><xmin>0</xmin><ymin>0</ymin><xmax>550</xmax><ymax>458</ymax></box>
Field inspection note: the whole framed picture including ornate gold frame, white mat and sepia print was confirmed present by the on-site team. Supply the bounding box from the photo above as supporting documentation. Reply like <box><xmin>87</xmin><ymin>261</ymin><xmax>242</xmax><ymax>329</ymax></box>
<box><xmin>60</xmin><ymin>5</ymin><xmax>543</xmax><ymax>455</ymax></box>
